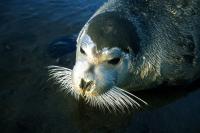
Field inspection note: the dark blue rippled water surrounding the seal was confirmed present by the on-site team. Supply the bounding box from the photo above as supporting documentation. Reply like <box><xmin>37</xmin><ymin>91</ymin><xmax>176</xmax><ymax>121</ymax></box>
<box><xmin>0</xmin><ymin>0</ymin><xmax>200</xmax><ymax>133</ymax></box>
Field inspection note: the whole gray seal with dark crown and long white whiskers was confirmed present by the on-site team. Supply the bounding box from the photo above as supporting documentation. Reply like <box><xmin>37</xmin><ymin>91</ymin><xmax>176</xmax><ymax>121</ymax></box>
<box><xmin>49</xmin><ymin>0</ymin><xmax>200</xmax><ymax>111</ymax></box>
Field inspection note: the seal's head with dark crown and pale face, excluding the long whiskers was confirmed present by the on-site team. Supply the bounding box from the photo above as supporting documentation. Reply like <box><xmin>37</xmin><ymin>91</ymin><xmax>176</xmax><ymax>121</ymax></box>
<box><xmin>72</xmin><ymin>12</ymin><xmax>146</xmax><ymax>108</ymax></box>
